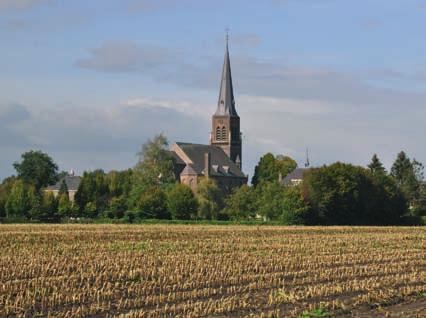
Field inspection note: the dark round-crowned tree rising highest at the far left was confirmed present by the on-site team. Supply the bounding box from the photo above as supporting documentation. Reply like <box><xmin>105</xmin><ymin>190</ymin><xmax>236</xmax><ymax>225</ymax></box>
<box><xmin>13</xmin><ymin>150</ymin><xmax>58</xmax><ymax>191</ymax></box>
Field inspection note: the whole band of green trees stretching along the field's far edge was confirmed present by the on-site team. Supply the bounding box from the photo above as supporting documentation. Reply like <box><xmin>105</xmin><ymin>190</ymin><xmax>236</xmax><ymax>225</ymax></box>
<box><xmin>0</xmin><ymin>135</ymin><xmax>426</xmax><ymax>225</ymax></box>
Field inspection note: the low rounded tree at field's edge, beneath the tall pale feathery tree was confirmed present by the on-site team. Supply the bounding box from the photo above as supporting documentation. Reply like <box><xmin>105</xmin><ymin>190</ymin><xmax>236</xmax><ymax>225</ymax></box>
<box><xmin>137</xmin><ymin>186</ymin><xmax>170</xmax><ymax>219</ymax></box>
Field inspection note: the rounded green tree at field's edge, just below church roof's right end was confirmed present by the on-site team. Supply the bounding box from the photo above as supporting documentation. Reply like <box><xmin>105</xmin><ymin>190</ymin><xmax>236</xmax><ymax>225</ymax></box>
<box><xmin>225</xmin><ymin>184</ymin><xmax>258</xmax><ymax>220</ymax></box>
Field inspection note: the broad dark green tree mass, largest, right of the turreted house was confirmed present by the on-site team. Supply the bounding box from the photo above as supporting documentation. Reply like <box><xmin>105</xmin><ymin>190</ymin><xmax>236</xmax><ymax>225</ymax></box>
<box><xmin>303</xmin><ymin>162</ymin><xmax>406</xmax><ymax>225</ymax></box>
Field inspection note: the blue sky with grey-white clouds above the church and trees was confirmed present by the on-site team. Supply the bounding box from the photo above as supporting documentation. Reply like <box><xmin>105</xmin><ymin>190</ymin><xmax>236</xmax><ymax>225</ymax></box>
<box><xmin>0</xmin><ymin>0</ymin><xmax>426</xmax><ymax>179</ymax></box>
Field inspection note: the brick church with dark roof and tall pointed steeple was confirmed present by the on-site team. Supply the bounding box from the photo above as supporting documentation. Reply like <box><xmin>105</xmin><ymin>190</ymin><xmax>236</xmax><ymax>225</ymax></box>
<box><xmin>170</xmin><ymin>40</ymin><xmax>248</xmax><ymax>193</ymax></box>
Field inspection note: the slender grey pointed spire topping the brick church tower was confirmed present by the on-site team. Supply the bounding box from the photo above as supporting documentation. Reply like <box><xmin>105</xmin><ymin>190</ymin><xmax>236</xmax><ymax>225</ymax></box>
<box><xmin>215</xmin><ymin>30</ymin><xmax>238</xmax><ymax>117</ymax></box>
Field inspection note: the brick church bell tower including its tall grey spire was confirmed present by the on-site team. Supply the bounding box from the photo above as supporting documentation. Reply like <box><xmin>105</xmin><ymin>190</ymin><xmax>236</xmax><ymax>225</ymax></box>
<box><xmin>210</xmin><ymin>34</ymin><xmax>242</xmax><ymax>169</ymax></box>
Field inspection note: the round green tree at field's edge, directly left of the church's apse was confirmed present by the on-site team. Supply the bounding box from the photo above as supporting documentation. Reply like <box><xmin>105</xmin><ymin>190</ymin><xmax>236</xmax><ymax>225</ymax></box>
<box><xmin>167</xmin><ymin>183</ymin><xmax>198</xmax><ymax>220</ymax></box>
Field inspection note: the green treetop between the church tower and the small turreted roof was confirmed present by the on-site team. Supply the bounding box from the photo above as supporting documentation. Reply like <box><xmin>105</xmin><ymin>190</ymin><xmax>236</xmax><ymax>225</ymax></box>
<box><xmin>251</xmin><ymin>153</ymin><xmax>297</xmax><ymax>186</ymax></box>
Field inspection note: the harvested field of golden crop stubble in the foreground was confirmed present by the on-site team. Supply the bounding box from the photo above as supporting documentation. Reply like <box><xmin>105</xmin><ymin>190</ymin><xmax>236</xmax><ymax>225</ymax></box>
<box><xmin>0</xmin><ymin>225</ymin><xmax>426</xmax><ymax>317</ymax></box>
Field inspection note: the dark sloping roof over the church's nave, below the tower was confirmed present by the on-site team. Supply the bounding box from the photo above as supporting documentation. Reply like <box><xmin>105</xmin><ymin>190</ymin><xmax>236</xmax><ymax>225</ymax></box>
<box><xmin>171</xmin><ymin>142</ymin><xmax>246</xmax><ymax>178</ymax></box>
